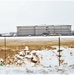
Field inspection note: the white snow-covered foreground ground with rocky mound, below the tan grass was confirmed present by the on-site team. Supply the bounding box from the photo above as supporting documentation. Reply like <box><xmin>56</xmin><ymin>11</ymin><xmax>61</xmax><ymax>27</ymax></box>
<box><xmin>0</xmin><ymin>46</ymin><xmax>74</xmax><ymax>74</ymax></box>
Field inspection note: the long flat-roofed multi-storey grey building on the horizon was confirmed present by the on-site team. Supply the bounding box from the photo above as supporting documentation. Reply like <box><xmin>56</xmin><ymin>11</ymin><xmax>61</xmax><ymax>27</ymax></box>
<box><xmin>17</xmin><ymin>25</ymin><xmax>71</xmax><ymax>36</ymax></box>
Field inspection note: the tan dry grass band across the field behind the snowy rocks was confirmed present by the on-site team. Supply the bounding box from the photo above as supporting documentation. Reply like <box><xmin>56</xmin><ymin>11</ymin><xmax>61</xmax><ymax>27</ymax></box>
<box><xmin>0</xmin><ymin>39</ymin><xmax>74</xmax><ymax>63</ymax></box>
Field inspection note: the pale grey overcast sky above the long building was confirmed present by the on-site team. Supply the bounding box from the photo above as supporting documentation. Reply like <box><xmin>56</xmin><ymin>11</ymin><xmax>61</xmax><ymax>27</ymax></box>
<box><xmin>0</xmin><ymin>1</ymin><xmax>74</xmax><ymax>33</ymax></box>
